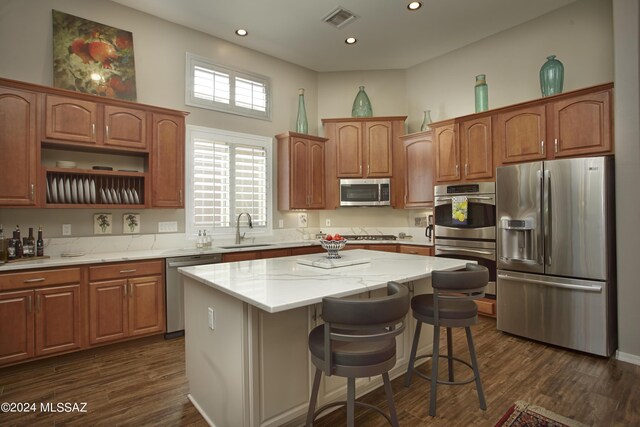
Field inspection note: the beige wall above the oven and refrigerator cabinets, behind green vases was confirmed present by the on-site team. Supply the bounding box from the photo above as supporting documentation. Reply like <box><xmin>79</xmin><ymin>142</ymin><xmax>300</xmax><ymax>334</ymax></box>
<box><xmin>406</xmin><ymin>0</ymin><xmax>613</xmax><ymax>132</ymax></box>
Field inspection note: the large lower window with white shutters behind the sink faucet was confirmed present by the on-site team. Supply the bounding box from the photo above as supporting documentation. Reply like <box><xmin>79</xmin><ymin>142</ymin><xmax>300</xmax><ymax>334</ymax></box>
<box><xmin>186</xmin><ymin>126</ymin><xmax>272</xmax><ymax>239</ymax></box>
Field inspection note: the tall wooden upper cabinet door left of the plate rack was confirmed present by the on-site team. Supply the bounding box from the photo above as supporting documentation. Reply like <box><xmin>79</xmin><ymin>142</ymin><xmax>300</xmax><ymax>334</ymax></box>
<box><xmin>0</xmin><ymin>86</ymin><xmax>38</xmax><ymax>206</ymax></box>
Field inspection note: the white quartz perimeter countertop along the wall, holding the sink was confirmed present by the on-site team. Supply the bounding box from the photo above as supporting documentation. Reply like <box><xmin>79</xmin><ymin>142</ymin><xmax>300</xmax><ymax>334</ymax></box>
<box><xmin>0</xmin><ymin>239</ymin><xmax>430</xmax><ymax>273</ymax></box>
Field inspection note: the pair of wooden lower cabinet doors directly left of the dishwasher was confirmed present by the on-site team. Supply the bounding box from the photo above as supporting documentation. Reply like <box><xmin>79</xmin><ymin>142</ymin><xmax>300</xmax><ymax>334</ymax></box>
<box><xmin>89</xmin><ymin>272</ymin><xmax>165</xmax><ymax>345</ymax></box>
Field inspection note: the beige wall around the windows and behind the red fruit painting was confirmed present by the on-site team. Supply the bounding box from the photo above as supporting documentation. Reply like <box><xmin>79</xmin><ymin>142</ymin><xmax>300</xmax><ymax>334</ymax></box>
<box><xmin>0</xmin><ymin>0</ymin><xmax>318</xmax><ymax>237</ymax></box>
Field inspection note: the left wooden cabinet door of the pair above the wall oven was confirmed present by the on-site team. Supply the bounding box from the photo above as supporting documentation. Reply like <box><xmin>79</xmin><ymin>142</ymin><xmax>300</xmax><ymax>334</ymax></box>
<box><xmin>433</xmin><ymin>123</ymin><xmax>461</xmax><ymax>182</ymax></box>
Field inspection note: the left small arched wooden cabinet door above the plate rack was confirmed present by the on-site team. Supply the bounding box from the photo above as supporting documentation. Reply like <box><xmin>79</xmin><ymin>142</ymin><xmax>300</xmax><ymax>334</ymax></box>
<box><xmin>45</xmin><ymin>95</ymin><xmax>101</xmax><ymax>144</ymax></box>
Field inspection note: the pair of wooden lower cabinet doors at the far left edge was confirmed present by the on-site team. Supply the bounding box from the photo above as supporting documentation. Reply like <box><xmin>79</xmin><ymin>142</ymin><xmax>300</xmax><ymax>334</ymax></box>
<box><xmin>0</xmin><ymin>283</ymin><xmax>82</xmax><ymax>365</ymax></box>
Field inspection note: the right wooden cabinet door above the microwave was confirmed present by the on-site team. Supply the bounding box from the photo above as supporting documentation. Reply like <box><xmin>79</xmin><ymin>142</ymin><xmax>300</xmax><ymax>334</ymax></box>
<box><xmin>362</xmin><ymin>121</ymin><xmax>393</xmax><ymax>178</ymax></box>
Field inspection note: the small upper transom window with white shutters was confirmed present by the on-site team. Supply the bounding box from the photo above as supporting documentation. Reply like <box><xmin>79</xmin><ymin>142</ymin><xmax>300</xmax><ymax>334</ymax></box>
<box><xmin>185</xmin><ymin>53</ymin><xmax>271</xmax><ymax>120</ymax></box>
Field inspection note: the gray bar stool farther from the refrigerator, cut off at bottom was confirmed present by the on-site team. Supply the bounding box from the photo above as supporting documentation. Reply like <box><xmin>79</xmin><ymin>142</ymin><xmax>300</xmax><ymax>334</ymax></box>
<box><xmin>306</xmin><ymin>282</ymin><xmax>409</xmax><ymax>427</ymax></box>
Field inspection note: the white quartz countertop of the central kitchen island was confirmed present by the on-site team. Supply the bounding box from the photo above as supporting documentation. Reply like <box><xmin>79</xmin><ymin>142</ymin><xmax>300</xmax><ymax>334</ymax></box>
<box><xmin>178</xmin><ymin>249</ymin><xmax>468</xmax><ymax>313</ymax></box>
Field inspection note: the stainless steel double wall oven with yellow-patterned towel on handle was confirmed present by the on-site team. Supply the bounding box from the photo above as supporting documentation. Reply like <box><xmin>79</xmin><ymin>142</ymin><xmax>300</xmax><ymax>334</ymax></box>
<box><xmin>434</xmin><ymin>182</ymin><xmax>496</xmax><ymax>297</ymax></box>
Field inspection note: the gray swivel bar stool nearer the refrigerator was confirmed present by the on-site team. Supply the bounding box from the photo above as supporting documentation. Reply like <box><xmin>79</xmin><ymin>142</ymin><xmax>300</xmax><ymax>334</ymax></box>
<box><xmin>405</xmin><ymin>264</ymin><xmax>489</xmax><ymax>417</ymax></box>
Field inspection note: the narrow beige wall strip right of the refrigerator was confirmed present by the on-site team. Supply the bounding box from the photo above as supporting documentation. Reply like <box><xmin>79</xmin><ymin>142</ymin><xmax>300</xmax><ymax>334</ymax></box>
<box><xmin>613</xmin><ymin>0</ymin><xmax>640</xmax><ymax>365</ymax></box>
